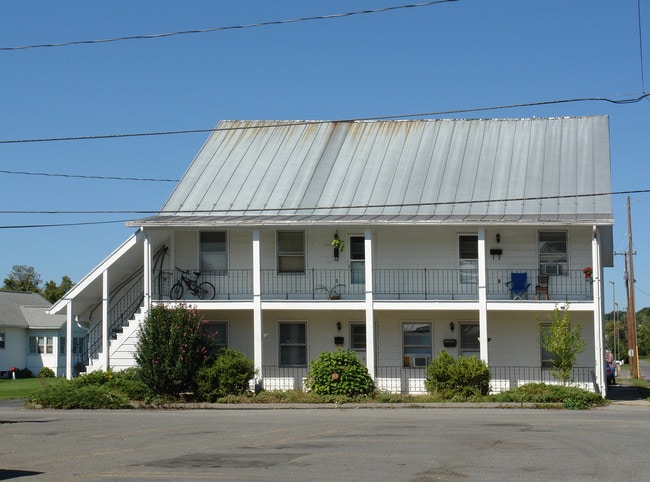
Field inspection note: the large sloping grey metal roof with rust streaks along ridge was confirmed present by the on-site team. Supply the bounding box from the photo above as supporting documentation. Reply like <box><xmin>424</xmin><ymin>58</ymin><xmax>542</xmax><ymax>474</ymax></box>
<box><xmin>128</xmin><ymin>116</ymin><xmax>613</xmax><ymax>226</ymax></box>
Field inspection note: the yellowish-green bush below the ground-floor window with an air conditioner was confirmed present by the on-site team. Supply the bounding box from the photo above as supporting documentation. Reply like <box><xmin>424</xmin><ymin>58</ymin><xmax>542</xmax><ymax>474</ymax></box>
<box><xmin>424</xmin><ymin>350</ymin><xmax>490</xmax><ymax>401</ymax></box>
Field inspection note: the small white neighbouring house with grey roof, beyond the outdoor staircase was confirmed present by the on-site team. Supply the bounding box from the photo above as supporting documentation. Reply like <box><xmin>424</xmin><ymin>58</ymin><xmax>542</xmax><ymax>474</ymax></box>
<box><xmin>0</xmin><ymin>291</ymin><xmax>86</xmax><ymax>378</ymax></box>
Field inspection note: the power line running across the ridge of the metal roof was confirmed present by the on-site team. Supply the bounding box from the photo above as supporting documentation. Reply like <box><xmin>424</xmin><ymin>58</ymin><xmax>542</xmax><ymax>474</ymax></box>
<box><xmin>0</xmin><ymin>92</ymin><xmax>650</xmax><ymax>144</ymax></box>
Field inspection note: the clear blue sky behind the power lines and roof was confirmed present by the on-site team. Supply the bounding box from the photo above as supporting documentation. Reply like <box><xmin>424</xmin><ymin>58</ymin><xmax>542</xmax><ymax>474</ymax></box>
<box><xmin>0</xmin><ymin>0</ymin><xmax>650</xmax><ymax>311</ymax></box>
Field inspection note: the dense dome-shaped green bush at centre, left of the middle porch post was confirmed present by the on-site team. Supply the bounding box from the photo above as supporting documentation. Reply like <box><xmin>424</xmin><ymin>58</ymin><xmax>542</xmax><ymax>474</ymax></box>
<box><xmin>306</xmin><ymin>350</ymin><xmax>375</xmax><ymax>397</ymax></box>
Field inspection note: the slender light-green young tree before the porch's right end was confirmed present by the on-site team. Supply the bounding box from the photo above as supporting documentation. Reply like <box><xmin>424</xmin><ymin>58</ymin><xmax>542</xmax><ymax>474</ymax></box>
<box><xmin>540</xmin><ymin>306</ymin><xmax>587</xmax><ymax>385</ymax></box>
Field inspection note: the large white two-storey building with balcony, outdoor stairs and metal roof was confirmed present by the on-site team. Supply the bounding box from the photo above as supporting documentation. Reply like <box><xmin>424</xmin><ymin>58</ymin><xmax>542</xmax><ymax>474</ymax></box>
<box><xmin>51</xmin><ymin>116</ymin><xmax>613</xmax><ymax>393</ymax></box>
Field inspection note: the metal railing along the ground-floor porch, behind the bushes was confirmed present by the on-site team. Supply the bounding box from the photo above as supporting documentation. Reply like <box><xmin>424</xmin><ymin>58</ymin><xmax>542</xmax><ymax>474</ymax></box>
<box><xmin>261</xmin><ymin>365</ymin><xmax>596</xmax><ymax>394</ymax></box>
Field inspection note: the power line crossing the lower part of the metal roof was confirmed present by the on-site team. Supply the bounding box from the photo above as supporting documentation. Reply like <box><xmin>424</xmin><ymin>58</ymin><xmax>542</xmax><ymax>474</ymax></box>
<box><xmin>0</xmin><ymin>189</ymin><xmax>650</xmax><ymax>215</ymax></box>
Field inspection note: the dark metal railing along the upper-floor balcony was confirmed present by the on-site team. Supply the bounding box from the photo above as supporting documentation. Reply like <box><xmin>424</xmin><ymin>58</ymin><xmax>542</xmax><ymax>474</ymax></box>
<box><xmin>153</xmin><ymin>268</ymin><xmax>593</xmax><ymax>302</ymax></box>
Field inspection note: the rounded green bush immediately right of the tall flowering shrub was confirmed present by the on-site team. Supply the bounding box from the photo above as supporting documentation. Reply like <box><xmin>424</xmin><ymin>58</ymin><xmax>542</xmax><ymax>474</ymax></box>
<box><xmin>196</xmin><ymin>348</ymin><xmax>255</xmax><ymax>402</ymax></box>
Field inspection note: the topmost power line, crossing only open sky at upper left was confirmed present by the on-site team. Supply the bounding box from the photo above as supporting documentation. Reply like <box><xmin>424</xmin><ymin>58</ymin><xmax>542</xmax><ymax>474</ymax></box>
<box><xmin>0</xmin><ymin>0</ymin><xmax>459</xmax><ymax>52</ymax></box>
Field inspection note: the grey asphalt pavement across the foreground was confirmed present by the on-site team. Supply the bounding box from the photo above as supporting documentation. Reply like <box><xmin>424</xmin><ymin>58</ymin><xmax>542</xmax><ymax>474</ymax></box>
<box><xmin>0</xmin><ymin>402</ymin><xmax>650</xmax><ymax>481</ymax></box>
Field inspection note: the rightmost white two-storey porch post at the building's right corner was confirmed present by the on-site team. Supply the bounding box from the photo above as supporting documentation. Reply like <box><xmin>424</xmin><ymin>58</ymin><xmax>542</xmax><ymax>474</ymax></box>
<box><xmin>591</xmin><ymin>226</ymin><xmax>607</xmax><ymax>396</ymax></box>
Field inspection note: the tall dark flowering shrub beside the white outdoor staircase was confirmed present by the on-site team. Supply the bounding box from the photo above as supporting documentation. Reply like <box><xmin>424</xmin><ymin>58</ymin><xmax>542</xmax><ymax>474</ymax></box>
<box><xmin>135</xmin><ymin>305</ymin><xmax>213</xmax><ymax>396</ymax></box>
